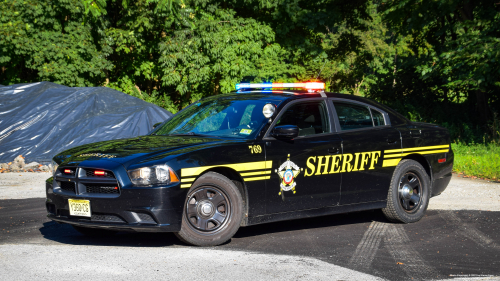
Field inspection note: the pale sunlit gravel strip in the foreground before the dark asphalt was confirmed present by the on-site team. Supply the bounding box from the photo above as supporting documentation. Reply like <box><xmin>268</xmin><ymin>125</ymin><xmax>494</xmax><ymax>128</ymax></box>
<box><xmin>0</xmin><ymin>242</ymin><xmax>382</xmax><ymax>280</ymax></box>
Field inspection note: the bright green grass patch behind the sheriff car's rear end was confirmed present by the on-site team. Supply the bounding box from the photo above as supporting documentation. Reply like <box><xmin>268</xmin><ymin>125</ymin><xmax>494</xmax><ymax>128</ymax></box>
<box><xmin>451</xmin><ymin>143</ymin><xmax>500</xmax><ymax>180</ymax></box>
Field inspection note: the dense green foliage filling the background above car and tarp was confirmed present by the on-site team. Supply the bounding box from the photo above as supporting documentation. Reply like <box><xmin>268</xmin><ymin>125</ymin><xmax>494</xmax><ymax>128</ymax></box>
<box><xmin>0</xmin><ymin>0</ymin><xmax>500</xmax><ymax>142</ymax></box>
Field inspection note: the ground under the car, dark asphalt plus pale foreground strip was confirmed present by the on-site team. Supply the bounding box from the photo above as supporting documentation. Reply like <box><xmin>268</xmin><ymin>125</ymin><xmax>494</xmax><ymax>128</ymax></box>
<box><xmin>0</xmin><ymin>195</ymin><xmax>500</xmax><ymax>280</ymax></box>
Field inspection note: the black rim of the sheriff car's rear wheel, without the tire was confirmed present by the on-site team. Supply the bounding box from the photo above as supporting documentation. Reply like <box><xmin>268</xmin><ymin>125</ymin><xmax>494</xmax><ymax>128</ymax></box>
<box><xmin>398</xmin><ymin>172</ymin><xmax>423</xmax><ymax>213</ymax></box>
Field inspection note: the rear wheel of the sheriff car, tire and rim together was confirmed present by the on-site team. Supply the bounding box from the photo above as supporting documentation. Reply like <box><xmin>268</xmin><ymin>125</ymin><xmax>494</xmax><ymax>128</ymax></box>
<box><xmin>382</xmin><ymin>159</ymin><xmax>431</xmax><ymax>223</ymax></box>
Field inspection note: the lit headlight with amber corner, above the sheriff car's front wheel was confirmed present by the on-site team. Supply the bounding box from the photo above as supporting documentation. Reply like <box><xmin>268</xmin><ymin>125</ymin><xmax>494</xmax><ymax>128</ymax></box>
<box><xmin>127</xmin><ymin>165</ymin><xmax>179</xmax><ymax>186</ymax></box>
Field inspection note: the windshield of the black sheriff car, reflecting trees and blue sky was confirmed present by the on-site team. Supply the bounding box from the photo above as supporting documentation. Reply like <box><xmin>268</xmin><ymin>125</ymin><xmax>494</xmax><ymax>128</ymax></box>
<box><xmin>153</xmin><ymin>98</ymin><xmax>268</xmax><ymax>139</ymax></box>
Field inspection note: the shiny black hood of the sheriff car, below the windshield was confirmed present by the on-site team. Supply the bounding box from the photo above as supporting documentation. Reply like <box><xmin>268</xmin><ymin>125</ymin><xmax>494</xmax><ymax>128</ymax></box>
<box><xmin>54</xmin><ymin>136</ymin><xmax>227</xmax><ymax>166</ymax></box>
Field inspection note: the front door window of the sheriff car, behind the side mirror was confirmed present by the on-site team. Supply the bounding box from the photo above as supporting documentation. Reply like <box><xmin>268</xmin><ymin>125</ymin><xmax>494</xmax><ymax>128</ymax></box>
<box><xmin>276</xmin><ymin>101</ymin><xmax>330</xmax><ymax>136</ymax></box>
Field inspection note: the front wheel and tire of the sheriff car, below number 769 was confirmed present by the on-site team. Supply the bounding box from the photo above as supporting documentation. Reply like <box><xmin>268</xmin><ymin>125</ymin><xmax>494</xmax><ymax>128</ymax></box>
<box><xmin>175</xmin><ymin>172</ymin><xmax>243</xmax><ymax>246</ymax></box>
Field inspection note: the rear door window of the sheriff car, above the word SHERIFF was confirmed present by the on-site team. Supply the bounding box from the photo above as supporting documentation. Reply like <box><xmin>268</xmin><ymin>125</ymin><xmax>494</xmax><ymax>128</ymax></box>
<box><xmin>333</xmin><ymin>102</ymin><xmax>374</xmax><ymax>130</ymax></box>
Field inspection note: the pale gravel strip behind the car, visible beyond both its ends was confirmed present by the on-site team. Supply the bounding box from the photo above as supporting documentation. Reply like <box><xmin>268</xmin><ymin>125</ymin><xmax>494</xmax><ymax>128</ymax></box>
<box><xmin>0</xmin><ymin>173</ymin><xmax>500</xmax><ymax>211</ymax></box>
